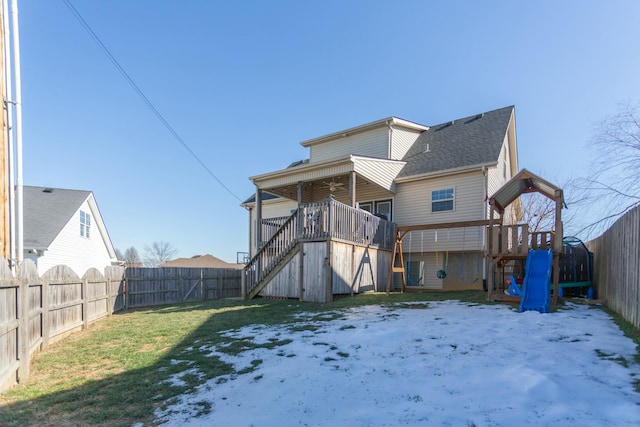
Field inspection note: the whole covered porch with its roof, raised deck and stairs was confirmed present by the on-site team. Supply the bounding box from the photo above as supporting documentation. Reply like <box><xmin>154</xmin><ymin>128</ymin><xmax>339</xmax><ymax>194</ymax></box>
<box><xmin>244</xmin><ymin>155</ymin><xmax>405</xmax><ymax>302</ymax></box>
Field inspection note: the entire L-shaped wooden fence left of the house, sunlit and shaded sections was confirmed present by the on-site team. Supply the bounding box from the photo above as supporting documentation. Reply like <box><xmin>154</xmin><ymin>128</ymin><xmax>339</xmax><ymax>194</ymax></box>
<box><xmin>0</xmin><ymin>260</ymin><xmax>241</xmax><ymax>393</ymax></box>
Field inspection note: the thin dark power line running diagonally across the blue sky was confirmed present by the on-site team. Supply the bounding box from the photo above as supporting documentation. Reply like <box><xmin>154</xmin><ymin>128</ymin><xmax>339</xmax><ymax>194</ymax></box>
<box><xmin>62</xmin><ymin>0</ymin><xmax>243</xmax><ymax>202</ymax></box>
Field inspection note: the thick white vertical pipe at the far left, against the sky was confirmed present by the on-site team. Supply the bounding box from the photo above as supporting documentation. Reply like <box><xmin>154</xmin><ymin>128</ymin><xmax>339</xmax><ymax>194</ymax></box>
<box><xmin>11</xmin><ymin>0</ymin><xmax>24</xmax><ymax>266</ymax></box>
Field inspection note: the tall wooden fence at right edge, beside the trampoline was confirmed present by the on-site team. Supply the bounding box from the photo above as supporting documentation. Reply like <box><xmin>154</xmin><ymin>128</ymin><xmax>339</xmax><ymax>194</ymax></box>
<box><xmin>587</xmin><ymin>206</ymin><xmax>640</xmax><ymax>328</ymax></box>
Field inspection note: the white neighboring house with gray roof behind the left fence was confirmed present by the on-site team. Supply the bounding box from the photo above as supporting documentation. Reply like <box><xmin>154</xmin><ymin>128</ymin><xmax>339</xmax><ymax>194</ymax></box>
<box><xmin>24</xmin><ymin>186</ymin><xmax>117</xmax><ymax>277</ymax></box>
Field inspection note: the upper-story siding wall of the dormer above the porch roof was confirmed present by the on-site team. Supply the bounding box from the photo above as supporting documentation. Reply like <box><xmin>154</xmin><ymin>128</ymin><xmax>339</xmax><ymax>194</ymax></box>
<box><xmin>309</xmin><ymin>128</ymin><xmax>389</xmax><ymax>163</ymax></box>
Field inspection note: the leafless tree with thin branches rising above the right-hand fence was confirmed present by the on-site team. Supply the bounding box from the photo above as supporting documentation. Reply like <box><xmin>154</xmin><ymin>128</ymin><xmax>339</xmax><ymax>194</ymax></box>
<box><xmin>581</xmin><ymin>103</ymin><xmax>640</xmax><ymax>234</ymax></box>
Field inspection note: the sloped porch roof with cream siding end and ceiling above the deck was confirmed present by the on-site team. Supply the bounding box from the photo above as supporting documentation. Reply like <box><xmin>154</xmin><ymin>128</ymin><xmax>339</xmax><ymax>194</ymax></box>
<box><xmin>250</xmin><ymin>155</ymin><xmax>405</xmax><ymax>202</ymax></box>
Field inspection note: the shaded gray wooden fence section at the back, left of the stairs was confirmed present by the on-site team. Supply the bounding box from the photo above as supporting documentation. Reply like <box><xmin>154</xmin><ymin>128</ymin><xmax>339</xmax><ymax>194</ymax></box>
<box><xmin>125</xmin><ymin>267</ymin><xmax>242</xmax><ymax>308</ymax></box>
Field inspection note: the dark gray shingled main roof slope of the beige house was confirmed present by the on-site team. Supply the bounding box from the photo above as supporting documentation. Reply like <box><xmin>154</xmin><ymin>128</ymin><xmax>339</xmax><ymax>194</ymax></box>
<box><xmin>398</xmin><ymin>106</ymin><xmax>514</xmax><ymax>178</ymax></box>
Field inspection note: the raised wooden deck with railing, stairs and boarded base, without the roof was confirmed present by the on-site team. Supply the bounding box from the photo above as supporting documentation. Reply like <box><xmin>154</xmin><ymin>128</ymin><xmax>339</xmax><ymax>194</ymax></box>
<box><xmin>243</xmin><ymin>199</ymin><xmax>396</xmax><ymax>302</ymax></box>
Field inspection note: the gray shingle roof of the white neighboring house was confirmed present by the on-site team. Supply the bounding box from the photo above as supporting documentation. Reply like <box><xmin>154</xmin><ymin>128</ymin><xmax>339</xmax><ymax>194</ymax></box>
<box><xmin>23</xmin><ymin>186</ymin><xmax>91</xmax><ymax>250</ymax></box>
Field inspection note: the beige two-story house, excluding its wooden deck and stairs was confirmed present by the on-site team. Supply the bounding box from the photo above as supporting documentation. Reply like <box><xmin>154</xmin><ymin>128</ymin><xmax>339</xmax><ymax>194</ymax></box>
<box><xmin>243</xmin><ymin>106</ymin><xmax>521</xmax><ymax>289</ymax></box>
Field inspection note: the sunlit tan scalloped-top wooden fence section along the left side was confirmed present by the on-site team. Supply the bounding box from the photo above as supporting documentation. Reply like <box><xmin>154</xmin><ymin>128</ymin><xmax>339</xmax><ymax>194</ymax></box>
<box><xmin>0</xmin><ymin>260</ymin><xmax>124</xmax><ymax>392</ymax></box>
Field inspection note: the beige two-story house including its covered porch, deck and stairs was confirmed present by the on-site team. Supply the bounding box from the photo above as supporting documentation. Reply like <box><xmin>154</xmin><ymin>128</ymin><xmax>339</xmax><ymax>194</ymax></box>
<box><xmin>243</xmin><ymin>106</ymin><xmax>520</xmax><ymax>300</ymax></box>
